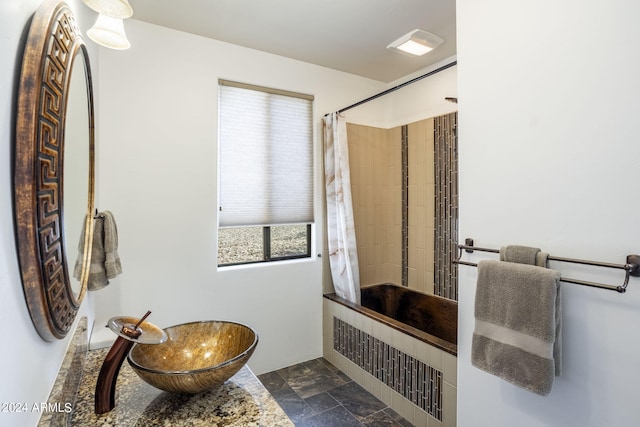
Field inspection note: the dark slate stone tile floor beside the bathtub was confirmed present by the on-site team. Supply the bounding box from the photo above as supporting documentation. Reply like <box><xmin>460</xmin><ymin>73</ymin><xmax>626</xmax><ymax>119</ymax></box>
<box><xmin>258</xmin><ymin>358</ymin><xmax>412</xmax><ymax>427</ymax></box>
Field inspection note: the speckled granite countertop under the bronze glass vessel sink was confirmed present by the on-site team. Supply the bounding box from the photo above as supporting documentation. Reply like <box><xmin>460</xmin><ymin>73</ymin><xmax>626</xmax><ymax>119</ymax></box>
<box><xmin>70</xmin><ymin>349</ymin><xmax>293</xmax><ymax>427</ymax></box>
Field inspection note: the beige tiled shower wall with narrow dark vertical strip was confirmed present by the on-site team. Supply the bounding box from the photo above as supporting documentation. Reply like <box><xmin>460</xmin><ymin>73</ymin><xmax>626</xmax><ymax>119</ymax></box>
<box><xmin>347</xmin><ymin>118</ymin><xmax>435</xmax><ymax>294</ymax></box>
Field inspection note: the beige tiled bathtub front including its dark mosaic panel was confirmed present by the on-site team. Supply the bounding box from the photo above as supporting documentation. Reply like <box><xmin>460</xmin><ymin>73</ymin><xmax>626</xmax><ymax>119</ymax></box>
<box><xmin>323</xmin><ymin>298</ymin><xmax>457</xmax><ymax>427</ymax></box>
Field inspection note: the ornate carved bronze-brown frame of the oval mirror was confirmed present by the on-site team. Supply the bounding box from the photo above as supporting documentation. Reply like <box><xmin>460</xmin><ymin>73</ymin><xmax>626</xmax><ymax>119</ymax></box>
<box><xmin>14</xmin><ymin>0</ymin><xmax>94</xmax><ymax>341</ymax></box>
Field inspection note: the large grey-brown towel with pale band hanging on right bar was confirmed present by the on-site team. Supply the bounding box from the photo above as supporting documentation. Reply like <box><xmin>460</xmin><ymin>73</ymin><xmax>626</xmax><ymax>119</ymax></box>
<box><xmin>471</xmin><ymin>260</ymin><xmax>560</xmax><ymax>396</ymax></box>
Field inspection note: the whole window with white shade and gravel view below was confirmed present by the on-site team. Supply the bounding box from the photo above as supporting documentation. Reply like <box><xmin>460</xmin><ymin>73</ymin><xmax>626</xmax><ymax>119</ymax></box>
<box><xmin>218</xmin><ymin>80</ymin><xmax>313</xmax><ymax>265</ymax></box>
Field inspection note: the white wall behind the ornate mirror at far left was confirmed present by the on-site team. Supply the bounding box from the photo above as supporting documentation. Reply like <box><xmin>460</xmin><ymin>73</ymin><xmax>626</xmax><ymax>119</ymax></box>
<box><xmin>0</xmin><ymin>0</ymin><xmax>93</xmax><ymax>427</ymax></box>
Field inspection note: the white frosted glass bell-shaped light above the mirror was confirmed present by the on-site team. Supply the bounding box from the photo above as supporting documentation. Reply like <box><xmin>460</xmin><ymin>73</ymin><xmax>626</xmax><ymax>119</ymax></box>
<box><xmin>82</xmin><ymin>0</ymin><xmax>133</xmax><ymax>50</ymax></box>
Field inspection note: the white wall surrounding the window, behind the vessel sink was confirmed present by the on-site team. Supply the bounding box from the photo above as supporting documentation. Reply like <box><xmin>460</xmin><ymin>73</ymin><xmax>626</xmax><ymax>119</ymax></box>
<box><xmin>92</xmin><ymin>20</ymin><xmax>385</xmax><ymax>373</ymax></box>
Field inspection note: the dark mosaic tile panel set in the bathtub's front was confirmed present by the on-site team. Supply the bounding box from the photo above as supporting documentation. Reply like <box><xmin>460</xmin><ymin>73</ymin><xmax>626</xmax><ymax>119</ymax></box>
<box><xmin>333</xmin><ymin>317</ymin><xmax>443</xmax><ymax>421</ymax></box>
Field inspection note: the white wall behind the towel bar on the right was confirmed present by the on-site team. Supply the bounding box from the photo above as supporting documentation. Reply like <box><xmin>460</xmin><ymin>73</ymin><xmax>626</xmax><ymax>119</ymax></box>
<box><xmin>457</xmin><ymin>0</ymin><xmax>640</xmax><ymax>427</ymax></box>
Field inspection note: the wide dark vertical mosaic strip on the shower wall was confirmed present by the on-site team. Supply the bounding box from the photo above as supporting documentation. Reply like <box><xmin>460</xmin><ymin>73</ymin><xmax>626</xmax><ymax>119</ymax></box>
<box><xmin>433</xmin><ymin>113</ymin><xmax>458</xmax><ymax>301</ymax></box>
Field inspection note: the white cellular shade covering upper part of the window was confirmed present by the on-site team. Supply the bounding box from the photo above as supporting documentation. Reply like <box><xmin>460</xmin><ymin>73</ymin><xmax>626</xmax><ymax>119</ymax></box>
<box><xmin>219</xmin><ymin>84</ymin><xmax>313</xmax><ymax>227</ymax></box>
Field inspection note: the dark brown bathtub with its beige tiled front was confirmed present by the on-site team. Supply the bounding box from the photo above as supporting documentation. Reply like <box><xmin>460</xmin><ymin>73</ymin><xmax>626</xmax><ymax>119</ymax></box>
<box><xmin>323</xmin><ymin>283</ymin><xmax>458</xmax><ymax>426</ymax></box>
